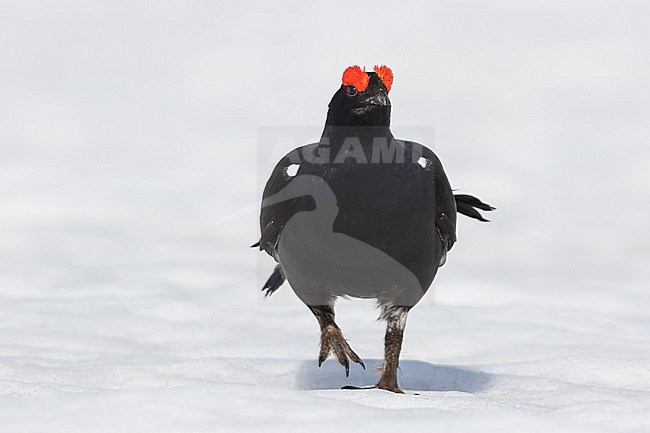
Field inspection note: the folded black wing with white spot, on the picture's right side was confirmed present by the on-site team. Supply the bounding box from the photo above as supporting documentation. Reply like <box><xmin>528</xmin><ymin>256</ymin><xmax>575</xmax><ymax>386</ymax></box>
<box><xmin>404</xmin><ymin>141</ymin><xmax>456</xmax><ymax>251</ymax></box>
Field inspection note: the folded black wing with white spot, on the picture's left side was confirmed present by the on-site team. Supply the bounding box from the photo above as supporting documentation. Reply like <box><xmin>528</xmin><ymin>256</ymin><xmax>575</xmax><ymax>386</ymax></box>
<box><xmin>253</xmin><ymin>143</ymin><xmax>316</xmax><ymax>258</ymax></box>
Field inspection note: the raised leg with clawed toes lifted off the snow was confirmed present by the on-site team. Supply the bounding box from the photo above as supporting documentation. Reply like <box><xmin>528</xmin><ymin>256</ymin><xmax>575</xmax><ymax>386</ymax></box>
<box><xmin>309</xmin><ymin>305</ymin><xmax>366</xmax><ymax>377</ymax></box>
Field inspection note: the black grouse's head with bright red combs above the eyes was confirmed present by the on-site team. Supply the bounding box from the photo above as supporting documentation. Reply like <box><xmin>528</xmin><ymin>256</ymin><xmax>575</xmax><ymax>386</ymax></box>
<box><xmin>326</xmin><ymin>65</ymin><xmax>393</xmax><ymax>126</ymax></box>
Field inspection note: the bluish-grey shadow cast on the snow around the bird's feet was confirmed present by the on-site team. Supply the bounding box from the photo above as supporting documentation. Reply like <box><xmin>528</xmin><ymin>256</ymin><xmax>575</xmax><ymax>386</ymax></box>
<box><xmin>296</xmin><ymin>359</ymin><xmax>492</xmax><ymax>393</ymax></box>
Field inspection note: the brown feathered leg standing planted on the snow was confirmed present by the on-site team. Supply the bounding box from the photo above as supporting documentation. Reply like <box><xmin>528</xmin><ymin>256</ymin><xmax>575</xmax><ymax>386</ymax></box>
<box><xmin>375</xmin><ymin>306</ymin><xmax>410</xmax><ymax>394</ymax></box>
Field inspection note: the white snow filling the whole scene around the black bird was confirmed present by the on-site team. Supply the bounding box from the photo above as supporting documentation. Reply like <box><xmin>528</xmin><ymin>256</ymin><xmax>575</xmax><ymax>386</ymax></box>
<box><xmin>0</xmin><ymin>1</ymin><xmax>650</xmax><ymax>433</ymax></box>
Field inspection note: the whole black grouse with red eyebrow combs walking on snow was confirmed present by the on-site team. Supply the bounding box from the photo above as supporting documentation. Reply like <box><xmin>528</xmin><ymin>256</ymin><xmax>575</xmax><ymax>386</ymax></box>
<box><xmin>255</xmin><ymin>66</ymin><xmax>493</xmax><ymax>393</ymax></box>
